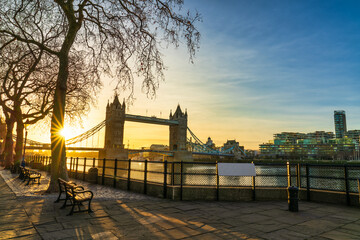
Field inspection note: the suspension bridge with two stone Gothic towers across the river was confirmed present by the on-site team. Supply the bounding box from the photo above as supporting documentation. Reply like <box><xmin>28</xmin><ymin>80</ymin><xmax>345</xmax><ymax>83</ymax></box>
<box><xmin>23</xmin><ymin>96</ymin><xmax>245</xmax><ymax>161</ymax></box>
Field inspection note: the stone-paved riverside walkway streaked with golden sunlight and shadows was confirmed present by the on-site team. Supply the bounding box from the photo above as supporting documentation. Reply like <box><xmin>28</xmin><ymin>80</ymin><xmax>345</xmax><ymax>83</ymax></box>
<box><xmin>0</xmin><ymin>170</ymin><xmax>360</xmax><ymax>240</ymax></box>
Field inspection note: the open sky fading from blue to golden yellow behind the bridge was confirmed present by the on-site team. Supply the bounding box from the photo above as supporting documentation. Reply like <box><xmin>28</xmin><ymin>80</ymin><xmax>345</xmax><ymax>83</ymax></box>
<box><xmin>28</xmin><ymin>0</ymin><xmax>360</xmax><ymax>149</ymax></box>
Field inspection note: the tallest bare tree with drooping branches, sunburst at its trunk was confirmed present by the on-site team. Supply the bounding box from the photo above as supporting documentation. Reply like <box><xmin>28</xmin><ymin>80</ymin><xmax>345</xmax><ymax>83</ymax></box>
<box><xmin>0</xmin><ymin>0</ymin><xmax>200</xmax><ymax>191</ymax></box>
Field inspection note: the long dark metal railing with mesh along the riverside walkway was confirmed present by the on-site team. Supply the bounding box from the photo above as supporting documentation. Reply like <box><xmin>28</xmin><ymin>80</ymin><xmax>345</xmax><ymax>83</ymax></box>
<box><xmin>27</xmin><ymin>156</ymin><xmax>360</xmax><ymax>205</ymax></box>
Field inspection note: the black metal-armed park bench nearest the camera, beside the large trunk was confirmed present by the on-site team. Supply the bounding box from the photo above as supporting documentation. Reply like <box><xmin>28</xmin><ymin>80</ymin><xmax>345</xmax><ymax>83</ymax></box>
<box><xmin>58</xmin><ymin>178</ymin><xmax>94</xmax><ymax>215</ymax></box>
